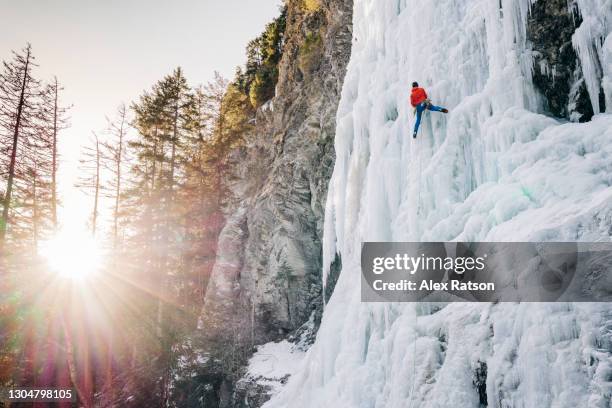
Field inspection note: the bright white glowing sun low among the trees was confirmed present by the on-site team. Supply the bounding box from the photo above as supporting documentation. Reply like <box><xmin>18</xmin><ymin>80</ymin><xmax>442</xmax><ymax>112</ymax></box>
<box><xmin>40</xmin><ymin>230</ymin><xmax>103</xmax><ymax>279</ymax></box>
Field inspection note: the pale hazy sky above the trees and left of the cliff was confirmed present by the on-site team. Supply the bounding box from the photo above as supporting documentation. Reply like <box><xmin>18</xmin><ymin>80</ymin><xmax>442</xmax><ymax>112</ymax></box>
<box><xmin>0</xmin><ymin>0</ymin><xmax>282</xmax><ymax>236</ymax></box>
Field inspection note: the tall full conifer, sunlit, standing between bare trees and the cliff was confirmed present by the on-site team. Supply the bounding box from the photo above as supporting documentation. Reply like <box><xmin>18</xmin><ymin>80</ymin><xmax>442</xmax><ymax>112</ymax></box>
<box><xmin>125</xmin><ymin>69</ymin><xmax>223</xmax><ymax>399</ymax></box>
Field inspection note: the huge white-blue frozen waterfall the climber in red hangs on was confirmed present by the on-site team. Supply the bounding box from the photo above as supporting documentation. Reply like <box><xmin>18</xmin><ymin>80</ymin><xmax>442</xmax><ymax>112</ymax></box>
<box><xmin>266</xmin><ymin>0</ymin><xmax>612</xmax><ymax>408</ymax></box>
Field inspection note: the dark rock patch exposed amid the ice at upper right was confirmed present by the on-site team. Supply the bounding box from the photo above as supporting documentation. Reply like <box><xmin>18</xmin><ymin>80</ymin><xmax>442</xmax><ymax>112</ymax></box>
<box><xmin>527</xmin><ymin>0</ymin><xmax>605</xmax><ymax>122</ymax></box>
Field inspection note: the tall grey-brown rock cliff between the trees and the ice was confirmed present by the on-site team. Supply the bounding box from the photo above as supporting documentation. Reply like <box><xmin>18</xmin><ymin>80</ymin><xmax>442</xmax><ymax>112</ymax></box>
<box><xmin>198</xmin><ymin>0</ymin><xmax>352</xmax><ymax>407</ymax></box>
